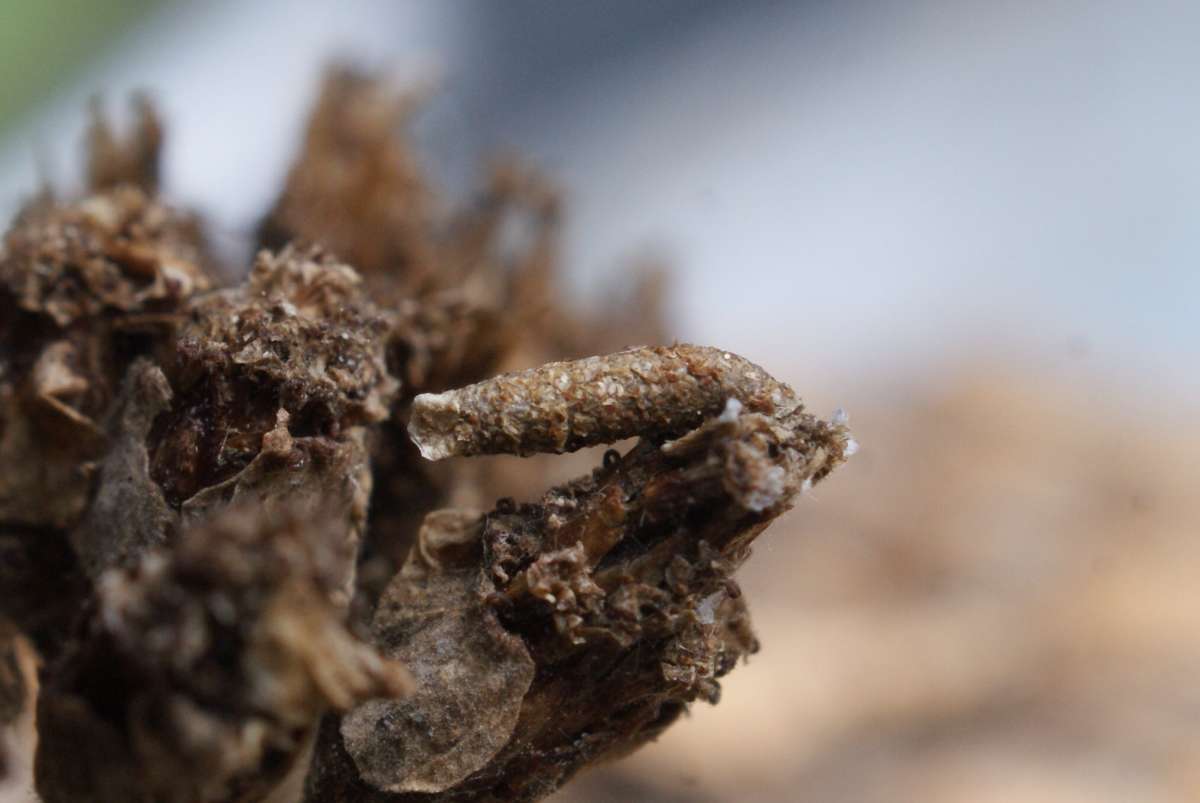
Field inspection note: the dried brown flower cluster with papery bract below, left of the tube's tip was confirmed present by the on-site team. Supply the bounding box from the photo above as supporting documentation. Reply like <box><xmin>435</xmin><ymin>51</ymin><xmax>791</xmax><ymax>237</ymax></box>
<box><xmin>148</xmin><ymin>248</ymin><xmax>396</xmax><ymax>600</ymax></box>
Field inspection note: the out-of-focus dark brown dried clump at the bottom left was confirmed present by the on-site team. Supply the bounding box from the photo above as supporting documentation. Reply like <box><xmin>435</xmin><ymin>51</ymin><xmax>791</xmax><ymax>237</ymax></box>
<box><xmin>36</xmin><ymin>509</ymin><xmax>410</xmax><ymax>803</ymax></box>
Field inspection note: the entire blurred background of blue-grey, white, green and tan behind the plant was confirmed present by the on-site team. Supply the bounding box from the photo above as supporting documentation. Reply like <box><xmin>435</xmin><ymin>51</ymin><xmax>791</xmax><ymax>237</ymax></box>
<box><xmin>0</xmin><ymin>0</ymin><xmax>1200</xmax><ymax>803</ymax></box>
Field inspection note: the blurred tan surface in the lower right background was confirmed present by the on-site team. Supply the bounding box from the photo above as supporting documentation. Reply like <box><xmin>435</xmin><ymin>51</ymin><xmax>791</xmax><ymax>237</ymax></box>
<box><xmin>556</xmin><ymin>372</ymin><xmax>1200</xmax><ymax>803</ymax></box>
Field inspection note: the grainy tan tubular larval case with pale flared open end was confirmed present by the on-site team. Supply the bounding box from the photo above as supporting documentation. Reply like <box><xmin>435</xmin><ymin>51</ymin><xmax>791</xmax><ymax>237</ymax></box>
<box><xmin>408</xmin><ymin>344</ymin><xmax>840</xmax><ymax>460</ymax></box>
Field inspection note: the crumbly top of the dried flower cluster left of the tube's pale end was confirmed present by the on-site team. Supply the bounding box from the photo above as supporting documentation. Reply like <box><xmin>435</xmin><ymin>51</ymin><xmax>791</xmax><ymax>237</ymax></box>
<box><xmin>150</xmin><ymin>250</ymin><xmax>395</xmax><ymax>496</ymax></box>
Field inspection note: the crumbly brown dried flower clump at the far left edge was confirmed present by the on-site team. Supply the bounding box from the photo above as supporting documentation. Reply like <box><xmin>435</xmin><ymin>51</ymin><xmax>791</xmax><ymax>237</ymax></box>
<box><xmin>0</xmin><ymin>187</ymin><xmax>209</xmax><ymax>527</ymax></box>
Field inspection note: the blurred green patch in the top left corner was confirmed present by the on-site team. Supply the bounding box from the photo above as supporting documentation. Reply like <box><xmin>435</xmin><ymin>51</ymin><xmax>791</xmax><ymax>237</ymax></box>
<box><xmin>0</xmin><ymin>0</ymin><xmax>162</xmax><ymax>133</ymax></box>
